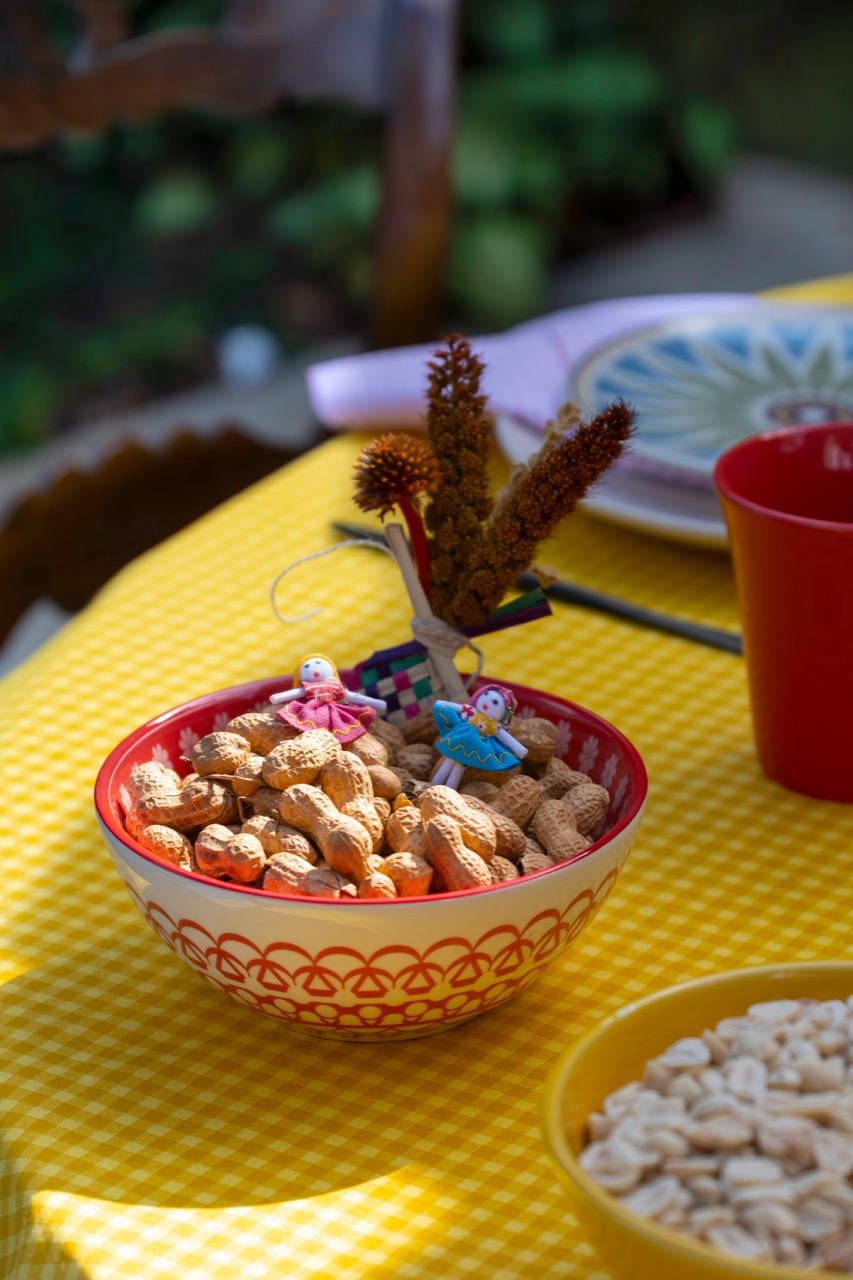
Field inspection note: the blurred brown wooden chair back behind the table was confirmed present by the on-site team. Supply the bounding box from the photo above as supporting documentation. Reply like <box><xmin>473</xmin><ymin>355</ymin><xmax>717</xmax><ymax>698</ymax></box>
<box><xmin>0</xmin><ymin>0</ymin><xmax>456</xmax><ymax>347</ymax></box>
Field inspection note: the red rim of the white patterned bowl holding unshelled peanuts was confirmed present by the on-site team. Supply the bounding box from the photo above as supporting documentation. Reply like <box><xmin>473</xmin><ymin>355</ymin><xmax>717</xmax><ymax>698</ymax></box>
<box><xmin>93</xmin><ymin>668</ymin><xmax>648</xmax><ymax>910</ymax></box>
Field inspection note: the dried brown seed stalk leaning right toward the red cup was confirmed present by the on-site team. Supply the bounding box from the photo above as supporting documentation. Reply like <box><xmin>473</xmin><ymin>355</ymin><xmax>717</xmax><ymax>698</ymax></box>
<box><xmin>442</xmin><ymin>401</ymin><xmax>637</xmax><ymax>626</ymax></box>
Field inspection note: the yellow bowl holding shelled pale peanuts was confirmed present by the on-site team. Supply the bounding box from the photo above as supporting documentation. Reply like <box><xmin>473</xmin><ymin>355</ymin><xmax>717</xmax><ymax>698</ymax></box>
<box><xmin>543</xmin><ymin>963</ymin><xmax>853</xmax><ymax>1280</ymax></box>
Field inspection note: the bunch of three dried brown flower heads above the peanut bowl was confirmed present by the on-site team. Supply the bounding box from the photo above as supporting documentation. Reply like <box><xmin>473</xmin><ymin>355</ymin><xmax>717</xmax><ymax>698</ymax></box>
<box><xmin>355</xmin><ymin>334</ymin><xmax>635</xmax><ymax>626</ymax></box>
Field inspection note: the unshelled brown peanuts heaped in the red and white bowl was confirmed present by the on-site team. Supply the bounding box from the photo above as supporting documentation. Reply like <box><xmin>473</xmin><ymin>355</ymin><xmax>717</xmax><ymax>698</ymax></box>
<box><xmin>126</xmin><ymin>710</ymin><xmax>610</xmax><ymax>899</ymax></box>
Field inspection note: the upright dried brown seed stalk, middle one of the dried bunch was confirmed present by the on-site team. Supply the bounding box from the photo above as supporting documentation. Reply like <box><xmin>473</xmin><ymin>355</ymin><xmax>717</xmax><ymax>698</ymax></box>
<box><xmin>425</xmin><ymin>334</ymin><xmax>492</xmax><ymax>620</ymax></box>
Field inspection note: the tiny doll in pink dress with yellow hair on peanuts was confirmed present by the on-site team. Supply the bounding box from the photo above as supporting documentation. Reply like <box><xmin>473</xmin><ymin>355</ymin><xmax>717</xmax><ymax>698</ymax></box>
<box><xmin>270</xmin><ymin>653</ymin><xmax>388</xmax><ymax>744</ymax></box>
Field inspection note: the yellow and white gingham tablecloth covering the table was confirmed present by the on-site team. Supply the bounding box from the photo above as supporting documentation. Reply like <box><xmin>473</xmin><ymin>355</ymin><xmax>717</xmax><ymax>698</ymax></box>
<box><xmin>0</xmin><ymin>278</ymin><xmax>853</xmax><ymax>1280</ymax></box>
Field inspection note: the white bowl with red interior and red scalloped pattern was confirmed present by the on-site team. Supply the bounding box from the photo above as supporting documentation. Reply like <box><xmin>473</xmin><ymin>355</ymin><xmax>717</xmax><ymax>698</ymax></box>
<box><xmin>95</xmin><ymin>672</ymin><xmax>647</xmax><ymax>1041</ymax></box>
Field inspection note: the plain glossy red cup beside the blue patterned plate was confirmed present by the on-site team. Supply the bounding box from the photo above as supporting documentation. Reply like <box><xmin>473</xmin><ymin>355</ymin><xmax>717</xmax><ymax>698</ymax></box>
<box><xmin>713</xmin><ymin>422</ymin><xmax>853</xmax><ymax>803</ymax></box>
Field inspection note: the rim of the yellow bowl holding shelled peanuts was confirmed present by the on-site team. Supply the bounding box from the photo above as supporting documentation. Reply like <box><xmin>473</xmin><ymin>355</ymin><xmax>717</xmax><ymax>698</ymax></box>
<box><xmin>540</xmin><ymin>960</ymin><xmax>853</xmax><ymax>1280</ymax></box>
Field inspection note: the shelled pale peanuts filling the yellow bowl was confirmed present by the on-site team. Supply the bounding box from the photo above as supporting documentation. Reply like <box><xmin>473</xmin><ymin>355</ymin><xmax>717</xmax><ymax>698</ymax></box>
<box><xmin>579</xmin><ymin>997</ymin><xmax>853</xmax><ymax>1274</ymax></box>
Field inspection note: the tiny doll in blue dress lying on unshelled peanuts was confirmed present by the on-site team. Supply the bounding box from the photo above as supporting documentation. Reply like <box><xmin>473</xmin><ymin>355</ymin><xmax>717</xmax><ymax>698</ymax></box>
<box><xmin>432</xmin><ymin>685</ymin><xmax>528</xmax><ymax>788</ymax></box>
